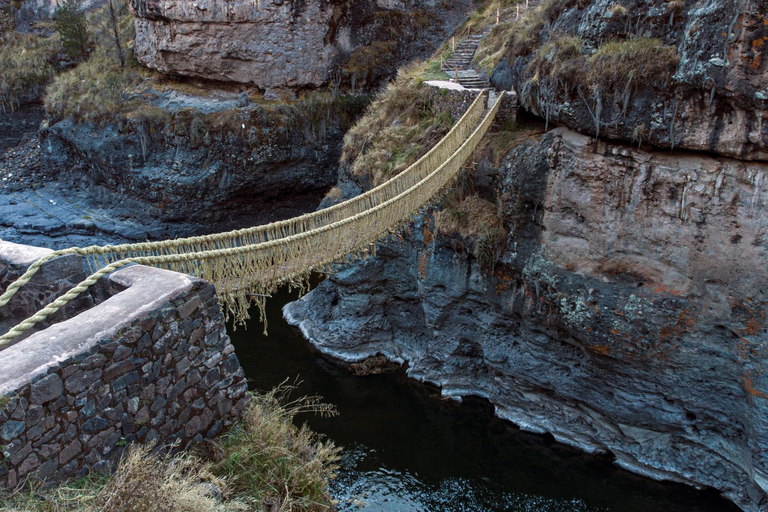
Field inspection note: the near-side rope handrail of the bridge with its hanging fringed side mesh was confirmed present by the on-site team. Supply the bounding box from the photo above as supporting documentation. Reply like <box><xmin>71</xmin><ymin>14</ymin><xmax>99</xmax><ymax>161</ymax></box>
<box><xmin>0</xmin><ymin>92</ymin><xmax>504</xmax><ymax>347</ymax></box>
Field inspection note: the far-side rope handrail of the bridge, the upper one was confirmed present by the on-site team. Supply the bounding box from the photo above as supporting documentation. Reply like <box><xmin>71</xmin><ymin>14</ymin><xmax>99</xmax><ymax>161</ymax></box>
<box><xmin>0</xmin><ymin>94</ymin><xmax>483</xmax><ymax>307</ymax></box>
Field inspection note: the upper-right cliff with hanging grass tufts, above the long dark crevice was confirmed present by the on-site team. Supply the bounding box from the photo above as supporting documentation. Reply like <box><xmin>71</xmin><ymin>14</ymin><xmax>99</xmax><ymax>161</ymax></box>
<box><xmin>492</xmin><ymin>0</ymin><xmax>768</xmax><ymax>160</ymax></box>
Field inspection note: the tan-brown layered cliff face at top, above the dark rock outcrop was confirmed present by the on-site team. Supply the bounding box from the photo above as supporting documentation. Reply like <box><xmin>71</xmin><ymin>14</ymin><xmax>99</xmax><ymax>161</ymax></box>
<box><xmin>133</xmin><ymin>0</ymin><xmax>470</xmax><ymax>90</ymax></box>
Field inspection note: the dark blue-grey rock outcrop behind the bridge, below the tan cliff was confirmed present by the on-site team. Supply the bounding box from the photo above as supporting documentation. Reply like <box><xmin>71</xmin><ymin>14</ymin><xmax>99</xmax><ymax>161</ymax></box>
<box><xmin>41</xmin><ymin>96</ymin><xmax>368</xmax><ymax>232</ymax></box>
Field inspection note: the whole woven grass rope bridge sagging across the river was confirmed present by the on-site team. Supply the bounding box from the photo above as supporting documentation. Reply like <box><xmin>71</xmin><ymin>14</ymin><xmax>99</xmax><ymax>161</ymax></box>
<box><xmin>0</xmin><ymin>93</ymin><xmax>503</xmax><ymax>347</ymax></box>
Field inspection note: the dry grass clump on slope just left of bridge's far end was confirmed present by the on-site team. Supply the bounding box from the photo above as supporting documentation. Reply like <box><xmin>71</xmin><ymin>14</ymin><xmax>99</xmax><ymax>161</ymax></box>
<box><xmin>342</xmin><ymin>64</ymin><xmax>454</xmax><ymax>185</ymax></box>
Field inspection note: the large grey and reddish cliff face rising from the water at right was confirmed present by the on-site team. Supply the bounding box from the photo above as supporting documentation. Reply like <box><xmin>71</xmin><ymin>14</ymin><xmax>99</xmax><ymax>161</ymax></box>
<box><xmin>285</xmin><ymin>128</ymin><xmax>768</xmax><ymax>511</ymax></box>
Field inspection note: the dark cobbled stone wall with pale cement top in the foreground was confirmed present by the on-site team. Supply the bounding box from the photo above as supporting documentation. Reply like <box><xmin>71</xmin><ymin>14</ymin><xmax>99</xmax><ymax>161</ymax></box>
<box><xmin>0</xmin><ymin>246</ymin><xmax>248</xmax><ymax>487</ymax></box>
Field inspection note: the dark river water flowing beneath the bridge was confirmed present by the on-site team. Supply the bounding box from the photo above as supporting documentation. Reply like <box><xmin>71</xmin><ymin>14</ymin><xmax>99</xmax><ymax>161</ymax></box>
<box><xmin>230</xmin><ymin>288</ymin><xmax>739</xmax><ymax>512</ymax></box>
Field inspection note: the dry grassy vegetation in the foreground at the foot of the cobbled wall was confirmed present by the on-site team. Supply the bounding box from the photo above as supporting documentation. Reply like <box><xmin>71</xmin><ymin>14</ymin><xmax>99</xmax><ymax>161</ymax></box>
<box><xmin>0</xmin><ymin>386</ymin><xmax>339</xmax><ymax>512</ymax></box>
